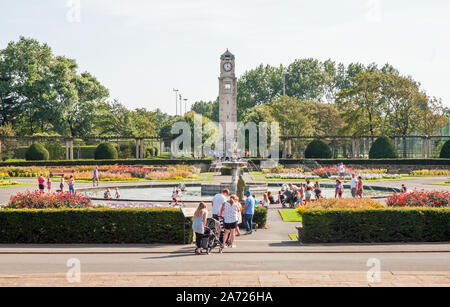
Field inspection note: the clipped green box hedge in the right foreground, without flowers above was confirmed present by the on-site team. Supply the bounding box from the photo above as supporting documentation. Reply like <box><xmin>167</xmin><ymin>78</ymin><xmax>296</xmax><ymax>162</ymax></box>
<box><xmin>300</xmin><ymin>208</ymin><xmax>450</xmax><ymax>243</ymax></box>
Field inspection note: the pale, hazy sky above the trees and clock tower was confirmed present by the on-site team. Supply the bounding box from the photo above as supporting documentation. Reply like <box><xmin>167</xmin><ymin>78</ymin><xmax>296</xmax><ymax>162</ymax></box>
<box><xmin>0</xmin><ymin>0</ymin><xmax>450</xmax><ymax>114</ymax></box>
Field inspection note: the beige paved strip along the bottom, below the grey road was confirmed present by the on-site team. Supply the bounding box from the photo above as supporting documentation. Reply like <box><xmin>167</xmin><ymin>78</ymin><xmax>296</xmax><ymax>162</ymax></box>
<box><xmin>0</xmin><ymin>271</ymin><xmax>450</xmax><ymax>287</ymax></box>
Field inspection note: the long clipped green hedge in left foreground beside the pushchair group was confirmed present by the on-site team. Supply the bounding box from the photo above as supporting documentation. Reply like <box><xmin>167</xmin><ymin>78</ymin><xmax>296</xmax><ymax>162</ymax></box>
<box><xmin>0</xmin><ymin>209</ymin><xmax>192</xmax><ymax>244</ymax></box>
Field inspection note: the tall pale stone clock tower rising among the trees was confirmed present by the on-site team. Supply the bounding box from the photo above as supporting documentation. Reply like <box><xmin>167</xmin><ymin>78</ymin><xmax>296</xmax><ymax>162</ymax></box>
<box><xmin>219</xmin><ymin>49</ymin><xmax>237</xmax><ymax>157</ymax></box>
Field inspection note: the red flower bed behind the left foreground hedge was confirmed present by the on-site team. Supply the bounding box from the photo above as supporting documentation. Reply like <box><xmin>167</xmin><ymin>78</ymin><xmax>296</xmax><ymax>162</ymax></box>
<box><xmin>7</xmin><ymin>191</ymin><xmax>92</xmax><ymax>209</ymax></box>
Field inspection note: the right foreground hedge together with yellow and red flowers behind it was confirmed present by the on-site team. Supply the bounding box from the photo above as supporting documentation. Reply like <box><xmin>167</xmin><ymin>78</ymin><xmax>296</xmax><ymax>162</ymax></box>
<box><xmin>297</xmin><ymin>191</ymin><xmax>450</xmax><ymax>243</ymax></box>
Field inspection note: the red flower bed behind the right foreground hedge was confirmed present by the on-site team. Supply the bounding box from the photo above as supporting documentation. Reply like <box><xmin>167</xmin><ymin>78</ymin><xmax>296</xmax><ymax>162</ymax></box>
<box><xmin>387</xmin><ymin>190</ymin><xmax>450</xmax><ymax>208</ymax></box>
